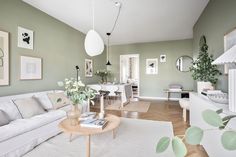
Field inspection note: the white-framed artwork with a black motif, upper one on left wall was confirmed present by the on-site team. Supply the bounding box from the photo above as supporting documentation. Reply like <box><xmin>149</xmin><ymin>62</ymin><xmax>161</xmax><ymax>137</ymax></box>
<box><xmin>18</xmin><ymin>27</ymin><xmax>34</xmax><ymax>50</ymax></box>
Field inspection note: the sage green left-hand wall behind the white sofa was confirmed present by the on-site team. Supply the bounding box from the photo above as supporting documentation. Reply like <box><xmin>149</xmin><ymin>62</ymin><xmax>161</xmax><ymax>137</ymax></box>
<box><xmin>0</xmin><ymin>0</ymin><xmax>106</xmax><ymax>96</ymax></box>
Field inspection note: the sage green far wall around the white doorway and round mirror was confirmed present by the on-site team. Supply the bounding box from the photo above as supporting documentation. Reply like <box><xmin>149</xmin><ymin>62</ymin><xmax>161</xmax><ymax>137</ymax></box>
<box><xmin>109</xmin><ymin>39</ymin><xmax>193</xmax><ymax>97</ymax></box>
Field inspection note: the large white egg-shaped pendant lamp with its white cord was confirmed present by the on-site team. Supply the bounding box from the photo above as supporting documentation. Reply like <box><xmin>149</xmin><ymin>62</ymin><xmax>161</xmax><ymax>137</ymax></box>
<box><xmin>84</xmin><ymin>0</ymin><xmax>104</xmax><ymax>57</ymax></box>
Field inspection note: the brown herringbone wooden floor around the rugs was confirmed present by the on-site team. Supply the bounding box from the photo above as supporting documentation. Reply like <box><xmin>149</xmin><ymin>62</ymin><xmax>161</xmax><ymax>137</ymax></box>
<box><xmin>91</xmin><ymin>100</ymin><xmax>208</xmax><ymax>157</ymax></box>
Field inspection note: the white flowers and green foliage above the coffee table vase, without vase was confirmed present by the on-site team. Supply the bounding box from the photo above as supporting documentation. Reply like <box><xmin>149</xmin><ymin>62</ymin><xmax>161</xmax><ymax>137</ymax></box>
<box><xmin>58</xmin><ymin>78</ymin><xmax>95</xmax><ymax>105</ymax></box>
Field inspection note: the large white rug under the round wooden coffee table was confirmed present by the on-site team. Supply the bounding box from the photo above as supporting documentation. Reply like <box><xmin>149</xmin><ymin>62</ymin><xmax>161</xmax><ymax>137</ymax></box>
<box><xmin>24</xmin><ymin>118</ymin><xmax>174</xmax><ymax>157</ymax></box>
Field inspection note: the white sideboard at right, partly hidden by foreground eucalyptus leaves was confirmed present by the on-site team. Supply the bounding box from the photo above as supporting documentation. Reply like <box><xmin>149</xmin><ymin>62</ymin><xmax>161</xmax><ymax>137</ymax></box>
<box><xmin>190</xmin><ymin>93</ymin><xmax>236</xmax><ymax>157</ymax></box>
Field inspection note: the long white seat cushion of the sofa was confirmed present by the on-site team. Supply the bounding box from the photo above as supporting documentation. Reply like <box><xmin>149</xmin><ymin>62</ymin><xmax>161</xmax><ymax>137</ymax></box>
<box><xmin>0</xmin><ymin>110</ymin><xmax>66</xmax><ymax>143</ymax></box>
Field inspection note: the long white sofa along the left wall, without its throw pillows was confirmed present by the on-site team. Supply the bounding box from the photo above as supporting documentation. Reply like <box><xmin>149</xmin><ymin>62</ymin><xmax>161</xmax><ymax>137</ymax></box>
<box><xmin>0</xmin><ymin>91</ymin><xmax>87</xmax><ymax>157</ymax></box>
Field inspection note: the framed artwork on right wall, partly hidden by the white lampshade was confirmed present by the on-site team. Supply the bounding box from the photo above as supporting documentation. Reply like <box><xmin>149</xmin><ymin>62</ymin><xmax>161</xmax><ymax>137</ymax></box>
<box><xmin>224</xmin><ymin>28</ymin><xmax>236</xmax><ymax>74</ymax></box>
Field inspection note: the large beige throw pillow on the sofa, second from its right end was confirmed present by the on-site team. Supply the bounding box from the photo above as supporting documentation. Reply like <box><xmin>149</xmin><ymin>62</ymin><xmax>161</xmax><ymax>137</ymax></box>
<box><xmin>13</xmin><ymin>97</ymin><xmax>46</xmax><ymax>118</ymax></box>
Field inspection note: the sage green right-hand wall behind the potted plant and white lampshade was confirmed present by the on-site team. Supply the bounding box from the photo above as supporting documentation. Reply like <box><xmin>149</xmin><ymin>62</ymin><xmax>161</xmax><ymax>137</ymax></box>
<box><xmin>193</xmin><ymin>0</ymin><xmax>236</xmax><ymax>91</ymax></box>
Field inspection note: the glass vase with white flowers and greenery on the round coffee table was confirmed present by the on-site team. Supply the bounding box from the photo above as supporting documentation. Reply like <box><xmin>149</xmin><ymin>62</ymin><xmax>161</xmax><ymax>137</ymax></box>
<box><xmin>57</xmin><ymin>78</ymin><xmax>95</xmax><ymax>125</ymax></box>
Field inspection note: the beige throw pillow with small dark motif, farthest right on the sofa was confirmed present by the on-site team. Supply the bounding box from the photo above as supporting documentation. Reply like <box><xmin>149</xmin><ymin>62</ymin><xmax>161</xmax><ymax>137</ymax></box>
<box><xmin>48</xmin><ymin>93</ymin><xmax>71</xmax><ymax>109</ymax></box>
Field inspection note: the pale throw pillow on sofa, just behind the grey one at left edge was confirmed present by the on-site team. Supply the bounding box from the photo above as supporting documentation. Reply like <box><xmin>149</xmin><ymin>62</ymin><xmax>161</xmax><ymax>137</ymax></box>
<box><xmin>0</xmin><ymin>100</ymin><xmax>22</xmax><ymax>121</ymax></box>
